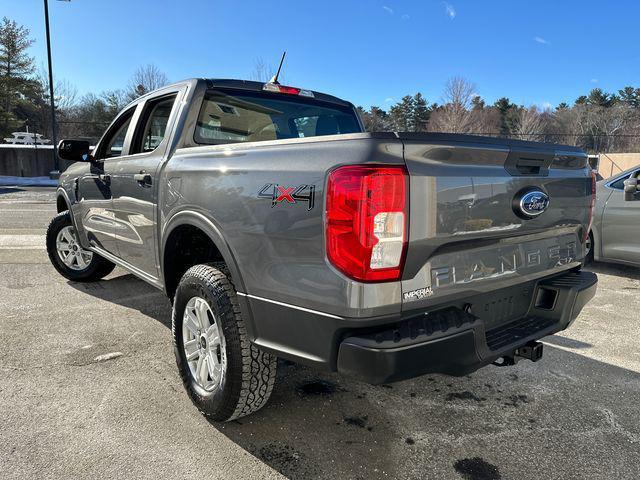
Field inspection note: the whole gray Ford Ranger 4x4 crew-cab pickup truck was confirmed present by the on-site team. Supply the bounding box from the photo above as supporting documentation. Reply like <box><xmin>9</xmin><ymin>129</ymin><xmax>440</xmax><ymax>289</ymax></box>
<box><xmin>47</xmin><ymin>79</ymin><xmax>597</xmax><ymax>421</ymax></box>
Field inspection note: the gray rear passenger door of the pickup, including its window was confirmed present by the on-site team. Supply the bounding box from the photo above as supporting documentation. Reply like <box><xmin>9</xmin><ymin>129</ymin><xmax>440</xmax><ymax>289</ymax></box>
<box><xmin>111</xmin><ymin>89</ymin><xmax>182</xmax><ymax>280</ymax></box>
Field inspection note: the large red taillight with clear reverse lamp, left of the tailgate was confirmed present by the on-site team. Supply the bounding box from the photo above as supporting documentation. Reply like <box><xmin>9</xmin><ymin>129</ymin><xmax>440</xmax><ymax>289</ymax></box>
<box><xmin>326</xmin><ymin>165</ymin><xmax>409</xmax><ymax>282</ymax></box>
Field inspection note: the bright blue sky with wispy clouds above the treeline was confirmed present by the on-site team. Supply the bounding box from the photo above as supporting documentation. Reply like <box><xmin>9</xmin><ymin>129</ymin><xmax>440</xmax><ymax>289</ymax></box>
<box><xmin>5</xmin><ymin>0</ymin><xmax>640</xmax><ymax>107</ymax></box>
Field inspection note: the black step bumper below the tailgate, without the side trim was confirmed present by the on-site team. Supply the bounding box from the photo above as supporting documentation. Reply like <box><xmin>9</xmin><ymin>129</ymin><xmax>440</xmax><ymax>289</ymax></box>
<box><xmin>337</xmin><ymin>272</ymin><xmax>598</xmax><ymax>384</ymax></box>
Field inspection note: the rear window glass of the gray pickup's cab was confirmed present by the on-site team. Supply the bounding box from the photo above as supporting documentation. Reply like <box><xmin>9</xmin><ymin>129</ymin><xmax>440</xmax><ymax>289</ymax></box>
<box><xmin>194</xmin><ymin>89</ymin><xmax>362</xmax><ymax>145</ymax></box>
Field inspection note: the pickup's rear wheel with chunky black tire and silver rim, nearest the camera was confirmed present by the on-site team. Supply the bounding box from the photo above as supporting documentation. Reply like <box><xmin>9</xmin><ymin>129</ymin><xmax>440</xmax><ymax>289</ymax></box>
<box><xmin>172</xmin><ymin>264</ymin><xmax>277</xmax><ymax>422</ymax></box>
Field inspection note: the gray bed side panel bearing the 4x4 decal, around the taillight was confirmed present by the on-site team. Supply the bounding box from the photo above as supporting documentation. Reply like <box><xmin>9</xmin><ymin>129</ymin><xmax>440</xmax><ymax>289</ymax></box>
<box><xmin>160</xmin><ymin>134</ymin><xmax>403</xmax><ymax>317</ymax></box>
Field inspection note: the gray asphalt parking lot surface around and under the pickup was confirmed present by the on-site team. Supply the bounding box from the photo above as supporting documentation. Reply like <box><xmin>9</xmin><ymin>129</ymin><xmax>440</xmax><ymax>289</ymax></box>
<box><xmin>0</xmin><ymin>187</ymin><xmax>640</xmax><ymax>479</ymax></box>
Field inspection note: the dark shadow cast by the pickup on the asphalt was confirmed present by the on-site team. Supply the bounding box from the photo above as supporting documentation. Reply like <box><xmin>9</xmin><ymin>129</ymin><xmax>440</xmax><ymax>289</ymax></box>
<box><xmin>70</xmin><ymin>275</ymin><xmax>640</xmax><ymax>480</ymax></box>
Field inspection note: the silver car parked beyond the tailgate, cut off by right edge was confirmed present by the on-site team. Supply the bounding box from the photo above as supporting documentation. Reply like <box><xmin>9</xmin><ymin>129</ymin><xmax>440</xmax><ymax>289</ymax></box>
<box><xmin>588</xmin><ymin>165</ymin><xmax>640</xmax><ymax>266</ymax></box>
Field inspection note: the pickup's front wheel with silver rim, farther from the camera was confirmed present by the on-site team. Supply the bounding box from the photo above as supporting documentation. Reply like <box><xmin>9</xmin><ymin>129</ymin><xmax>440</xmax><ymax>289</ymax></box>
<box><xmin>47</xmin><ymin>211</ymin><xmax>115</xmax><ymax>282</ymax></box>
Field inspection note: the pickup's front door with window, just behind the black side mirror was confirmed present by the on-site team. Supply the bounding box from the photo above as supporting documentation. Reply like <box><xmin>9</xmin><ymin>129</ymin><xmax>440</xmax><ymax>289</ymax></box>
<box><xmin>74</xmin><ymin>107</ymin><xmax>135</xmax><ymax>255</ymax></box>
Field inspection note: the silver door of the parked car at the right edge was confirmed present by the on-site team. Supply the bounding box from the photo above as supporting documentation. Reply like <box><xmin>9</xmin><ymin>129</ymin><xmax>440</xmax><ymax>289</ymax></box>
<box><xmin>602</xmin><ymin>169</ymin><xmax>640</xmax><ymax>265</ymax></box>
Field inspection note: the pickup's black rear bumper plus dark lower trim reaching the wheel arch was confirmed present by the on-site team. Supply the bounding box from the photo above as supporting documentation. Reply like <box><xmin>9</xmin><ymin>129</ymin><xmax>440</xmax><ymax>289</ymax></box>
<box><xmin>239</xmin><ymin>271</ymin><xmax>598</xmax><ymax>384</ymax></box>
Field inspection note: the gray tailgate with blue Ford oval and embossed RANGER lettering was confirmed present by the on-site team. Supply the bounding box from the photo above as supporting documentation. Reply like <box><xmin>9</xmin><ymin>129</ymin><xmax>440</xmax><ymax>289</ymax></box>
<box><xmin>399</xmin><ymin>134</ymin><xmax>592</xmax><ymax>310</ymax></box>
